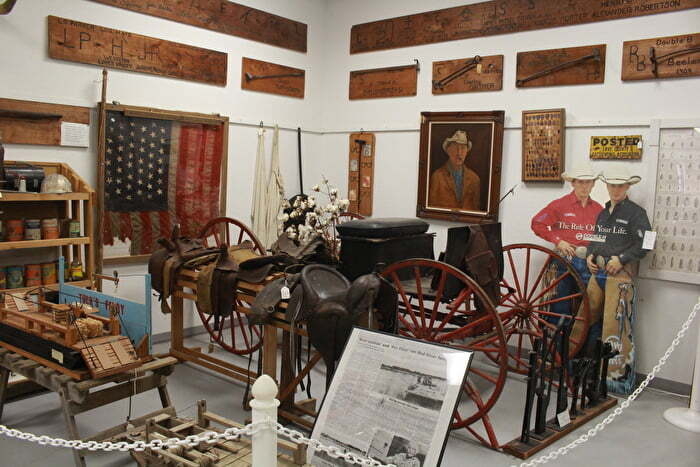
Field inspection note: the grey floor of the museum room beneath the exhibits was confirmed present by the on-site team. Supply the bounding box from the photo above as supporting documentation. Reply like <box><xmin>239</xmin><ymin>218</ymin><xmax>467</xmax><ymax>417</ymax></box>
<box><xmin>0</xmin><ymin>335</ymin><xmax>700</xmax><ymax>467</ymax></box>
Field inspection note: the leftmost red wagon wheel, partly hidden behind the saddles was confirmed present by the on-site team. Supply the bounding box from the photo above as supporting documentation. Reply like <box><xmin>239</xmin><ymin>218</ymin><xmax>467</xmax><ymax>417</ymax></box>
<box><xmin>197</xmin><ymin>217</ymin><xmax>265</xmax><ymax>355</ymax></box>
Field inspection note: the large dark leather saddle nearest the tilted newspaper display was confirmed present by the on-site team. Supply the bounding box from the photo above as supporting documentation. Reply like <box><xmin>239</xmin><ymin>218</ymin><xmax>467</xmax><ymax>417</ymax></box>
<box><xmin>249</xmin><ymin>264</ymin><xmax>398</xmax><ymax>385</ymax></box>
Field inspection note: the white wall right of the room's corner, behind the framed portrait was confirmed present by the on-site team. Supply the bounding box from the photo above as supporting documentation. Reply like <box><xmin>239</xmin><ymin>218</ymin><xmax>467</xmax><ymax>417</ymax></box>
<box><xmin>316</xmin><ymin>0</ymin><xmax>700</xmax><ymax>384</ymax></box>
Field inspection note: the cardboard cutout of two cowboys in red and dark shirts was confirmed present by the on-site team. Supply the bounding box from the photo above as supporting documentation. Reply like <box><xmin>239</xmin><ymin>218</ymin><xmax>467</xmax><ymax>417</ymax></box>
<box><xmin>532</xmin><ymin>165</ymin><xmax>650</xmax><ymax>394</ymax></box>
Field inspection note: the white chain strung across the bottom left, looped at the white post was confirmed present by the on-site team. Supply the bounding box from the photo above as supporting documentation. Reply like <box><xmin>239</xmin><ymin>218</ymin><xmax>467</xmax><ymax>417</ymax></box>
<box><xmin>0</xmin><ymin>418</ymin><xmax>396</xmax><ymax>467</ymax></box>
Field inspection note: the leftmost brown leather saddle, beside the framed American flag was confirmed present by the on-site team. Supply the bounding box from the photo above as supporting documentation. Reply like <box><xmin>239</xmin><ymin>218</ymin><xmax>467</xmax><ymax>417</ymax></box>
<box><xmin>148</xmin><ymin>225</ymin><xmax>220</xmax><ymax>313</ymax></box>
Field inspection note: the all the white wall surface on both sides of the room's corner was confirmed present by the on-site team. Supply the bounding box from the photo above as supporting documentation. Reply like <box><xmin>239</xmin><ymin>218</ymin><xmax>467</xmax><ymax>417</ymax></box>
<box><xmin>0</xmin><ymin>0</ymin><xmax>700</xmax><ymax>383</ymax></box>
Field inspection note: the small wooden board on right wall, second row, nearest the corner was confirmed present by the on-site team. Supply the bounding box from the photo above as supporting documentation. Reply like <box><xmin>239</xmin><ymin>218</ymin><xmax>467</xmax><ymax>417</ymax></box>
<box><xmin>350</xmin><ymin>65</ymin><xmax>418</xmax><ymax>100</ymax></box>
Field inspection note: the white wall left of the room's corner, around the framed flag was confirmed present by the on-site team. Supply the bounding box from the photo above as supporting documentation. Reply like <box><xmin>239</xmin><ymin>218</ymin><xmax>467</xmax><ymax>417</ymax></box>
<box><xmin>0</xmin><ymin>0</ymin><xmax>325</xmax><ymax>333</ymax></box>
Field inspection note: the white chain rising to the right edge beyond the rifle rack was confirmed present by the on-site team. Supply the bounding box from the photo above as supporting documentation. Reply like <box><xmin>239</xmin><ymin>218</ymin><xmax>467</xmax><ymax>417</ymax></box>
<box><xmin>511</xmin><ymin>303</ymin><xmax>700</xmax><ymax>467</ymax></box>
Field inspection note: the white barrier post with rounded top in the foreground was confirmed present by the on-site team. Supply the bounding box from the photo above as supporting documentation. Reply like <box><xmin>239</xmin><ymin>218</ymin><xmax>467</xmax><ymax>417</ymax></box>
<box><xmin>250</xmin><ymin>375</ymin><xmax>280</xmax><ymax>467</ymax></box>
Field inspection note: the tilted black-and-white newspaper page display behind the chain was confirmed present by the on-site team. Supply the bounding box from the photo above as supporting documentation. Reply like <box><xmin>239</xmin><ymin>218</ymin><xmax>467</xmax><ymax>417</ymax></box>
<box><xmin>309</xmin><ymin>328</ymin><xmax>471</xmax><ymax>467</ymax></box>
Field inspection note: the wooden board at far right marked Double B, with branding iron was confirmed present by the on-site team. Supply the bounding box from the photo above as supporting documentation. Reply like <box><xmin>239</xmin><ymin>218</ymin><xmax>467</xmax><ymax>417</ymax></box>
<box><xmin>622</xmin><ymin>33</ymin><xmax>700</xmax><ymax>81</ymax></box>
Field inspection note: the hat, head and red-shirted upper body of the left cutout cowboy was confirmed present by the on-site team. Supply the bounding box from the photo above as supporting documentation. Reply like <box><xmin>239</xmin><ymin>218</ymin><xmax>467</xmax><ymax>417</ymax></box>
<box><xmin>531</xmin><ymin>164</ymin><xmax>603</xmax><ymax>260</ymax></box>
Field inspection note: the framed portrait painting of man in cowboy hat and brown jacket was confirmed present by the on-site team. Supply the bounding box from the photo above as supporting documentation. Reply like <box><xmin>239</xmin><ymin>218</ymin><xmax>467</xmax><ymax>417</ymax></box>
<box><xmin>416</xmin><ymin>110</ymin><xmax>504</xmax><ymax>223</ymax></box>
